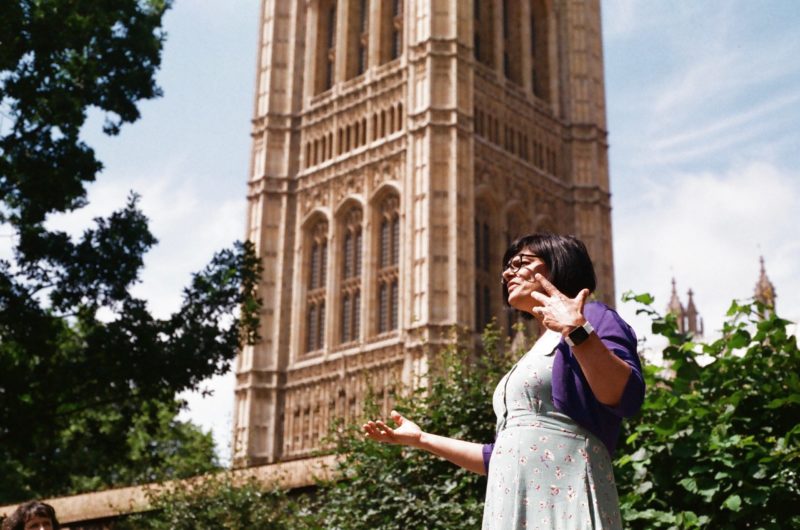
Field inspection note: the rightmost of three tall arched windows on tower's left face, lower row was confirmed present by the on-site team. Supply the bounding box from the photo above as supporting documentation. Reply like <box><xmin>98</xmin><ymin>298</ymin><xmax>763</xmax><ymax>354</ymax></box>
<box><xmin>377</xmin><ymin>195</ymin><xmax>400</xmax><ymax>333</ymax></box>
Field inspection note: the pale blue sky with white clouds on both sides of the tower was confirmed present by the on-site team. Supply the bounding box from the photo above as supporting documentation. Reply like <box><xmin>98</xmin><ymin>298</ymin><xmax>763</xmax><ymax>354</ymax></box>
<box><xmin>20</xmin><ymin>0</ymin><xmax>800</xmax><ymax>462</ymax></box>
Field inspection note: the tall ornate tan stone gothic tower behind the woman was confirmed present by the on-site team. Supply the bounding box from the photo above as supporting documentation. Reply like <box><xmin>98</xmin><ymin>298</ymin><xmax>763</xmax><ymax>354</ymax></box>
<box><xmin>233</xmin><ymin>0</ymin><xmax>614</xmax><ymax>465</ymax></box>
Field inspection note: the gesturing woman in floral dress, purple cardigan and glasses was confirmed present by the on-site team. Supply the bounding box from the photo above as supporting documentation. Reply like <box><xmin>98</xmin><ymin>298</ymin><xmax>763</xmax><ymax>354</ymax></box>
<box><xmin>362</xmin><ymin>234</ymin><xmax>644</xmax><ymax>529</ymax></box>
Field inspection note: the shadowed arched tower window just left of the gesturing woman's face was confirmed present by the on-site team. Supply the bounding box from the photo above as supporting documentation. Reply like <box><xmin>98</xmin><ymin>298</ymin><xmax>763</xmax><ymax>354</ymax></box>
<box><xmin>474</xmin><ymin>202</ymin><xmax>499</xmax><ymax>332</ymax></box>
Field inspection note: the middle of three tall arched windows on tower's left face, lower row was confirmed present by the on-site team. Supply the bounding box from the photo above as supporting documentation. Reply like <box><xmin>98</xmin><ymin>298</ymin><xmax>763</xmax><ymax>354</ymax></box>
<box><xmin>339</xmin><ymin>207</ymin><xmax>363</xmax><ymax>343</ymax></box>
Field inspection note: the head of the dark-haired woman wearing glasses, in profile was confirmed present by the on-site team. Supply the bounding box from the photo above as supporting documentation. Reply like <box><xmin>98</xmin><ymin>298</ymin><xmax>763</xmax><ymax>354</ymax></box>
<box><xmin>503</xmin><ymin>234</ymin><xmax>597</xmax><ymax>312</ymax></box>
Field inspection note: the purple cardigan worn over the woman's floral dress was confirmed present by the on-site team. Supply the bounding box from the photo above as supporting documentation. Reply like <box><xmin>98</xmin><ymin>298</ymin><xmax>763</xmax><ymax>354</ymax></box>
<box><xmin>483</xmin><ymin>302</ymin><xmax>644</xmax><ymax>472</ymax></box>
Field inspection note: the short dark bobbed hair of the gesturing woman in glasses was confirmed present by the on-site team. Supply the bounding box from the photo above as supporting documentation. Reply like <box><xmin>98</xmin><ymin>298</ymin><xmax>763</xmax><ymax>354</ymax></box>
<box><xmin>503</xmin><ymin>234</ymin><xmax>597</xmax><ymax>300</ymax></box>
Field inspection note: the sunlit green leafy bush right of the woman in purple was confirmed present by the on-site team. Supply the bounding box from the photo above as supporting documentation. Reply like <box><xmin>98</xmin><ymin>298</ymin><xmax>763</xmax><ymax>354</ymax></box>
<box><xmin>616</xmin><ymin>295</ymin><xmax>800</xmax><ymax>529</ymax></box>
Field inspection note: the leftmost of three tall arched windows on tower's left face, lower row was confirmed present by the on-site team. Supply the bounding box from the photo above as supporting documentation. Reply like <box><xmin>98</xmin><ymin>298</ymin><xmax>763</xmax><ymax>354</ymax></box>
<box><xmin>305</xmin><ymin>220</ymin><xmax>328</xmax><ymax>353</ymax></box>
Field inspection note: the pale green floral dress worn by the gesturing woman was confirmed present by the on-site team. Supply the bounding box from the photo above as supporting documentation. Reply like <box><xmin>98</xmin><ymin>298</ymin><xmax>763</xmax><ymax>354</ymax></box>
<box><xmin>483</xmin><ymin>331</ymin><xmax>622</xmax><ymax>530</ymax></box>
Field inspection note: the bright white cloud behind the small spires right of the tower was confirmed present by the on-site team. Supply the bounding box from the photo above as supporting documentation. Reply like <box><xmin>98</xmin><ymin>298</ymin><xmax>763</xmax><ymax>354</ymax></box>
<box><xmin>614</xmin><ymin>162</ymin><xmax>800</xmax><ymax>335</ymax></box>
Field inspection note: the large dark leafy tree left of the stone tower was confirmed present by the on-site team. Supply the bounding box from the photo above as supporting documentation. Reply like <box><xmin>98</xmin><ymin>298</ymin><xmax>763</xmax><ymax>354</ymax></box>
<box><xmin>0</xmin><ymin>0</ymin><xmax>260</xmax><ymax>502</ymax></box>
